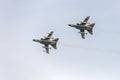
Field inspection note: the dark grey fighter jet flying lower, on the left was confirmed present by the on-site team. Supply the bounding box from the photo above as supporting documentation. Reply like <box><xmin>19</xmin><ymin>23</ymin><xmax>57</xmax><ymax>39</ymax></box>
<box><xmin>33</xmin><ymin>31</ymin><xmax>59</xmax><ymax>54</ymax></box>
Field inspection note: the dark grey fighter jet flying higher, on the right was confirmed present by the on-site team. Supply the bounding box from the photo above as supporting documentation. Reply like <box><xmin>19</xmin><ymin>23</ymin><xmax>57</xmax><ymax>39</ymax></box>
<box><xmin>68</xmin><ymin>16</ymin><xmax>95</xmax><ymax>39</ymax></box>
